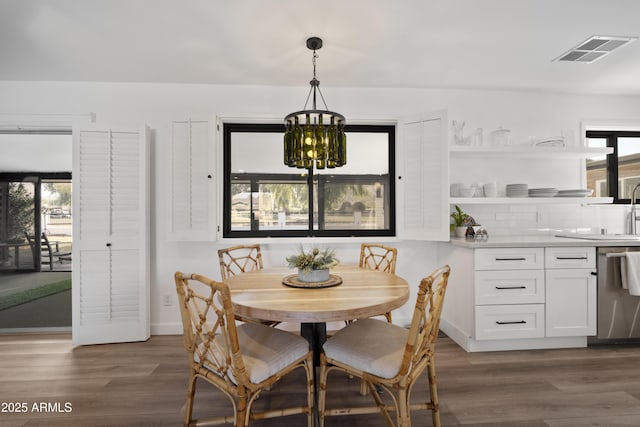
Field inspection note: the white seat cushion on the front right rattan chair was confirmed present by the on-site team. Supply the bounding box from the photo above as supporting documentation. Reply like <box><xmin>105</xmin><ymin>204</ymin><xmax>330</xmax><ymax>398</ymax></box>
<box><xmin>323</xmin><ymin>319</ymin><xmax>409</xmax><ymax>378</ymax></box>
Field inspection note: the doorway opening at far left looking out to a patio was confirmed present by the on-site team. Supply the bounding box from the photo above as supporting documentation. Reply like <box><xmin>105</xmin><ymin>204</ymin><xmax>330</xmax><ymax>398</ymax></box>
<box><xmin>0</xmin><ymin>132</ymin><xmax>73</xmax><ymax>332</ymax></box>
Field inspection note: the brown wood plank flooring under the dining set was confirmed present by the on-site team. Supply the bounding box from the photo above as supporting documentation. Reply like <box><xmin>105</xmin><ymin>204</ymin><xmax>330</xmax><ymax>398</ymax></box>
<box><xmin>0</xmin><ymin>334</ymin><xmax>640</xmax><ymax>427</ymax></box>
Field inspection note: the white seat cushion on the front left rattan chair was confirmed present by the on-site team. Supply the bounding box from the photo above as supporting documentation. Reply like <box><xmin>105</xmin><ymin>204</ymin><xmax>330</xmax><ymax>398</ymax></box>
<box><xmin>200</xmin><ymin>323</ymin><xmax>309</xmax><ymax>384</ymax></box>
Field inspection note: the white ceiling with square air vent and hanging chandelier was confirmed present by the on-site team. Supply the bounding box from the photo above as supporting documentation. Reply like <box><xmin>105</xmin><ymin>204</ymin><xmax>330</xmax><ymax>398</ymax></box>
<box><xmin>0</xmin><ymin>0</ymin><xmax>640</xmax><ymax>95</ymax></box>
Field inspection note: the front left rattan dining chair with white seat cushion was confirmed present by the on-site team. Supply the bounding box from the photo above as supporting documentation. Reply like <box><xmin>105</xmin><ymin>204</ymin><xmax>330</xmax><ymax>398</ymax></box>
<box><xmin>175</xmin><ymin>272</ymin><xmax>314</xmax><ymax>427</ymax></box>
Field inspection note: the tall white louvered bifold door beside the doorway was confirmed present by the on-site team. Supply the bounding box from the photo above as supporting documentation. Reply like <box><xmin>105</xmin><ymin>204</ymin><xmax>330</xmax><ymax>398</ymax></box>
<box><xmin>72</xmin><ymin>128</ymin><xmax>150</xmax><ymax>344</ymax></box>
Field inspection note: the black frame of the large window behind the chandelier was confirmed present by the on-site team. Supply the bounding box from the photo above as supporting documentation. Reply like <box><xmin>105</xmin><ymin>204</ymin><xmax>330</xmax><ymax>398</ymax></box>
<box><xmin>222</xmin><ymin>122</ymin><xmax>397</xmax><ymax>239</ymax></box>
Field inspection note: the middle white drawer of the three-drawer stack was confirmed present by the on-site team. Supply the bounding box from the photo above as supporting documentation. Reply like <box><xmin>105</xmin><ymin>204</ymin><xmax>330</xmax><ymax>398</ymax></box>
<box><xmin>475</xmin><ymin>270</ymin><xmax>545</xmax><ymax>305</ymax></box>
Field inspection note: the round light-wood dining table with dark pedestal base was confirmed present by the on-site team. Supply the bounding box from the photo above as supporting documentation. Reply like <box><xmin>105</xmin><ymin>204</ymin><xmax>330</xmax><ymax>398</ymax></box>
<box><xmin>225</xmin><ymin>265</ymin><xmax>409</xmax><ymax>361</ymax></box>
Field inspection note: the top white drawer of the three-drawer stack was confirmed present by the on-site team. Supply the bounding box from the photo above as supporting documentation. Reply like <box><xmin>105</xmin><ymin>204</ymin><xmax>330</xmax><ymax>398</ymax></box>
<box><xmin>474</xmin><ymin>248</ymin><xmax>544</xmax><ymax>270</ymax></box>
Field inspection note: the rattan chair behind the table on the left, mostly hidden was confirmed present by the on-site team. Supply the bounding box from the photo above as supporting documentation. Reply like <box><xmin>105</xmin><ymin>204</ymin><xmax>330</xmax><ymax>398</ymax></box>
<box><xmin>218</xmin><ymin>245</ymin><xmax>280</xmax><ymax>326</ymax></box>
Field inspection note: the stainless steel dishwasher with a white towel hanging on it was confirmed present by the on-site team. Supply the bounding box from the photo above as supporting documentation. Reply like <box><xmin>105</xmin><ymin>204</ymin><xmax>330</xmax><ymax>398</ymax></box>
<box><xmin>588</xmin><ymin>246</ymin><xmax>640</xmax><ymax>344</ymax></box>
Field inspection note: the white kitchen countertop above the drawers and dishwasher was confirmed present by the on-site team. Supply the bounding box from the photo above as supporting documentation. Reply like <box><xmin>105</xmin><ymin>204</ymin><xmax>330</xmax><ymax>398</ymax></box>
<box><xmin>451</xmin><ymin>234</ymin><xmax>640</xmax><ymax>249</ymax></box>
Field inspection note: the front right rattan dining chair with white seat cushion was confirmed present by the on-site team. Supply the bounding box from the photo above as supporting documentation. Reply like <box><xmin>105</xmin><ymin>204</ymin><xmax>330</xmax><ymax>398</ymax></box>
<box><xmin>318</xmin><ymin>265</ymin><xmax>450</xmax><ymax>427</ymax></box>
